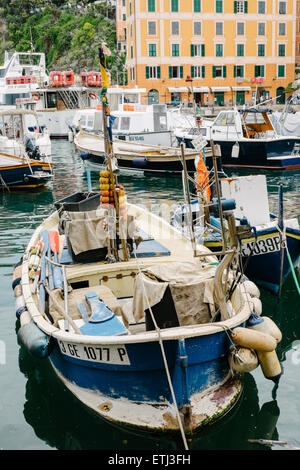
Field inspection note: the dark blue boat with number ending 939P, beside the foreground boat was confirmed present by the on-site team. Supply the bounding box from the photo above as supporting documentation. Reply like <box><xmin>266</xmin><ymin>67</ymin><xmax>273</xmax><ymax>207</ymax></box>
<box><xmin>171</xmin><ymin>175</ymin><xmax>300</xmax><ymax>294</ymax></box>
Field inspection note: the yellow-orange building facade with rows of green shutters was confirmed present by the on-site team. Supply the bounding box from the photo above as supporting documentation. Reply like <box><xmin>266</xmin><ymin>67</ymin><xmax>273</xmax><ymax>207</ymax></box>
<box><xmin>126</xmin><ymin>0</ymin><xmax>297</xmax><ymax>106</ymax></box>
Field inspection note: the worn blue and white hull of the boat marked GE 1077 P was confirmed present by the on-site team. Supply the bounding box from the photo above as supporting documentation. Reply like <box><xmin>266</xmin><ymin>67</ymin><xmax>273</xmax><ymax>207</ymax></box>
<box><xmin>50</xmin><ymin>322</ymin><xmax>244</xmax><ymax>432</ymax></box>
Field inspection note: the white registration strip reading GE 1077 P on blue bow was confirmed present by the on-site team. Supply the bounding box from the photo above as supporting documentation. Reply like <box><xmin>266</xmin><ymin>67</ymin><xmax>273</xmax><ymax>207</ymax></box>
<box><xmin>58</xmin><ymin>341</ymin><xmax>130</xmax><ymax>365</ymax></box>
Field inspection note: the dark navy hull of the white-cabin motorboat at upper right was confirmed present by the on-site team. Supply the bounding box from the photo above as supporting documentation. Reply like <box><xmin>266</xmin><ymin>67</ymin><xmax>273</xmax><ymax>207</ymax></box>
<box><xmin>178</xmin><ymin>137</ymin><xmax>300</xmax><ymax>170</ymax></box>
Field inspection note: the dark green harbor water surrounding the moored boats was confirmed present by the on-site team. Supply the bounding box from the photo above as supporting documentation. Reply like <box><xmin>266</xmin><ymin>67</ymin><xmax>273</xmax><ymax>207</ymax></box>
<box><xmin>0</xmin><ymin>141</ymin><xmax>300</xmax><ymax>451</ymax></box>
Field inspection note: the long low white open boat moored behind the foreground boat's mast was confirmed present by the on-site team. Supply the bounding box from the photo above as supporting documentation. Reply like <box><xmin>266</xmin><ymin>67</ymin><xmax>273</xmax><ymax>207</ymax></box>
<box><xmin>74</xmin><ymin>129</ymin><xmax>206</xmax><ymax>174</ymax></box>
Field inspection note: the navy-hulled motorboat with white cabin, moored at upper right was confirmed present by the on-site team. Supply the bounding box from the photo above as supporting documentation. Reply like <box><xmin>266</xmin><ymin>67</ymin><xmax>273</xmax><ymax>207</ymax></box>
<box><xmin>177</xmin><ymin>108</ymin><xmax>300</xmax><ymax>170</ymax></box>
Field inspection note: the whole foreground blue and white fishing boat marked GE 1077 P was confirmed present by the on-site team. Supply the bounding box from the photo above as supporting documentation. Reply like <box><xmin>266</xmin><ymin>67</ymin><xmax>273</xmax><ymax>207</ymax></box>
<box><xmin>13</xmin><ymin>49</ymin><xmax>281</xmax><ymax>442</ymax></box>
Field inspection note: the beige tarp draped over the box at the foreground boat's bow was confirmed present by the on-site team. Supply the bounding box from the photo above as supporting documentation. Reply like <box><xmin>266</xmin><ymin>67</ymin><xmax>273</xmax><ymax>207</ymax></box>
<box><xmin>133</xmin><ymin>260</ymin><xmax>216</xmax><ymax>326</ymax></box>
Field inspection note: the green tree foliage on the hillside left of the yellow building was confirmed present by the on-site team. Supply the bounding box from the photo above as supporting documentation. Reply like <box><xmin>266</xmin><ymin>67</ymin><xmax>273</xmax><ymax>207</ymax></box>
<box><xmin>0</xmin><ymin>0</ymin><xmax>125</xmax><ymax>83</ymax></box>
